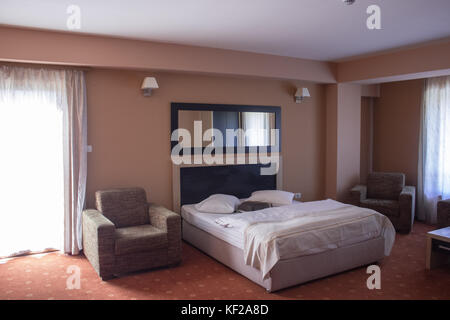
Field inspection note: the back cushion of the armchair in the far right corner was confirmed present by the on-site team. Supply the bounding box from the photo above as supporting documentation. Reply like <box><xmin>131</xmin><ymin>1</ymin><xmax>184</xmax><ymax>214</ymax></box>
<box><xmin>367</xmin><ymin>172</ymin><xmax>405</xmax><ymax>200</ymax></box>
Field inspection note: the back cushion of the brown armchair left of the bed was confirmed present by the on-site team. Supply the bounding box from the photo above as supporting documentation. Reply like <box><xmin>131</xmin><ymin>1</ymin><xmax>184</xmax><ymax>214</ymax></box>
<box><xmin>95</xmin><ymin>188</ymin><xmax>150</xmax><ymax>228</ymax></box>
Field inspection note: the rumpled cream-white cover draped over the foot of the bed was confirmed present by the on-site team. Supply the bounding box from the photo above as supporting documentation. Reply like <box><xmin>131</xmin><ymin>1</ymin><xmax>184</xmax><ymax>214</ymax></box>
<box><xmin>216</xmin><ymin>199</ymin><xmax>395</xmax><ymax>279</ymax></box>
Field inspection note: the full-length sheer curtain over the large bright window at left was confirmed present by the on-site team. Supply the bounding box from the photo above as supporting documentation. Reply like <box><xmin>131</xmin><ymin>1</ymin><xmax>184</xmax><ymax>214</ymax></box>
<box><xmin>0</xmin><ymin>65</ymin><xmax>86</xmax><ymax>256</ymax></box>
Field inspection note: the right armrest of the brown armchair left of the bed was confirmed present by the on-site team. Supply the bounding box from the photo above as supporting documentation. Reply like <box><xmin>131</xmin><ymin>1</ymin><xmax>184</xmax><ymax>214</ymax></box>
<box><xmin>148</xmin><ymin>203</ymin><xmax>181</xmax><ymax>264</ymax></box>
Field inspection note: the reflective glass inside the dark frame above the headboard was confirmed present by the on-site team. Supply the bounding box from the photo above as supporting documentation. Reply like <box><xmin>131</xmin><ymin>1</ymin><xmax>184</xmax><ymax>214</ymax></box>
<box><xmin>178</xmin><ymin>110</ymin><xmax>276</xmax><ymax>147</ymax></box>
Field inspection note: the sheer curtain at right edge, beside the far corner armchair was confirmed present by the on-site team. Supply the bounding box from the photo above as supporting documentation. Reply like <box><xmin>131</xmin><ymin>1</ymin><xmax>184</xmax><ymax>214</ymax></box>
<box><xmin>418</xmin><ymin>77</ymin><xmax>450</xmax><ymax>224</ymax></box>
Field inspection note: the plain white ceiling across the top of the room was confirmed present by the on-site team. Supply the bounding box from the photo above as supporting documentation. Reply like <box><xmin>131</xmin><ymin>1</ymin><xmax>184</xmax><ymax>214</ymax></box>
<box><xmin>0</xmin><ymin>0</ymin><xmax>450</xmax><ymax>60</ymax></box>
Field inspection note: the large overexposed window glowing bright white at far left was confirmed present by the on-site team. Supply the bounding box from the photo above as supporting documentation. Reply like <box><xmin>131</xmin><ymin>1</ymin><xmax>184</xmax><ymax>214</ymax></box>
<box><xmin>0</xmin><ymin>75</ymin><xmax>64</xmax><ymax>257</ymax></box>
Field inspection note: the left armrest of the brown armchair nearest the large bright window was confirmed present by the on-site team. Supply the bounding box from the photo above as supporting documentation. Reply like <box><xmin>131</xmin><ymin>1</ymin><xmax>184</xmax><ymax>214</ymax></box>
<box><xmin>82</xmin><ymin>209</ymin><xmax>116</xmax><ymax>280</ymax></box>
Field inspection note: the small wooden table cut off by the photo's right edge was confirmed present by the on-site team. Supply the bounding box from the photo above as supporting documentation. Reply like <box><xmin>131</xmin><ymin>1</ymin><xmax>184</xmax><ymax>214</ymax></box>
<box><xmin>426</xmin><ymin>227</ymin><xmax>450</xmax><ymax>269</ymax></box>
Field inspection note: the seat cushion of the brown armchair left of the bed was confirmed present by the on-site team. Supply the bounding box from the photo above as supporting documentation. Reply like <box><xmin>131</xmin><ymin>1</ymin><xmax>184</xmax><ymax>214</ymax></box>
<box><xmin>115</xmin><ymin>224</ymin><xmax>168</xmax><ymax>255</ymax></box>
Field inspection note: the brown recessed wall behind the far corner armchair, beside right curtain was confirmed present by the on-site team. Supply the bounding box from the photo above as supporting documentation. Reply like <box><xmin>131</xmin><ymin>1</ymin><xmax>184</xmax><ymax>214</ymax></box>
<box><xmin>373</xmin><ymin>79</ymin><xmax>424</xmax><ymax>186</ymax></box>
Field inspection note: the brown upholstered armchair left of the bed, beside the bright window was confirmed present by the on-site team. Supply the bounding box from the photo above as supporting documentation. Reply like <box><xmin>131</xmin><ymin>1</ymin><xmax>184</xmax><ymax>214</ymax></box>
<box><xmin>82</xmin><ymin>188</ymin><xmax>181</xmax><ymax>280</ymax></box>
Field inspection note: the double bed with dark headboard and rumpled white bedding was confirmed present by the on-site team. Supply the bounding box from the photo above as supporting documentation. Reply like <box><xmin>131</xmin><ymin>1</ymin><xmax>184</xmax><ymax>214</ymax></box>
<box><xmin>173</xmin><ymin>164</ymin><xmax>395</xmax><ymax>292</ymax></box>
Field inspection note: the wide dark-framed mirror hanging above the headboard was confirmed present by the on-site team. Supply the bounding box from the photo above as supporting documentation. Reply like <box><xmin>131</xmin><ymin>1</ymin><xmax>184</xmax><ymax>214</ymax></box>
<box><xmin>171</xmin><ymin>103</ymin><xmax>281</xmax><ymax>153</ymax></box>
